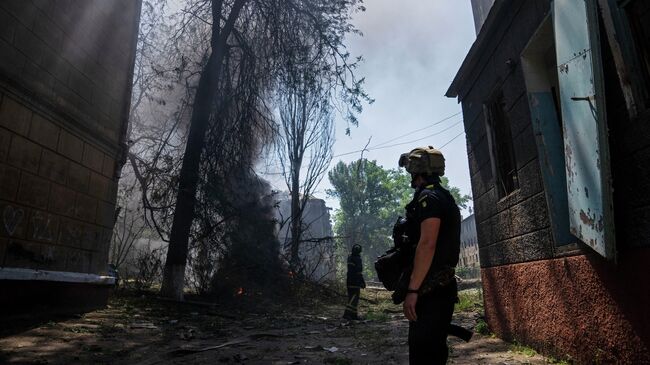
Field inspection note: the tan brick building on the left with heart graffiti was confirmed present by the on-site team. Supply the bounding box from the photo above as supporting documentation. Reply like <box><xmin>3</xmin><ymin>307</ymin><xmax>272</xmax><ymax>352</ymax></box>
<box><xmin>0</xmin><ymin>0</ymin><xmax>141</xmax><ymax>315</ymax></box>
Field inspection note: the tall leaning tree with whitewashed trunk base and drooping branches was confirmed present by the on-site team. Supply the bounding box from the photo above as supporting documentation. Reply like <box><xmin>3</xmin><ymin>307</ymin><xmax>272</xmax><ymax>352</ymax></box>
<box><xmin>148</xmin><ymin>0</ymin><xmax>368</xmax><ymax>299</ymax></box>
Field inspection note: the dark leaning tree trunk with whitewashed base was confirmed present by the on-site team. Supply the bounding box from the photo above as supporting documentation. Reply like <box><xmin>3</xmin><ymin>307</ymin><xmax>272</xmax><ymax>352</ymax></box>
<box><xmin>160</xmin><ymin>0</ymin><xmax>246</xmax><ymax>300</ymax></box>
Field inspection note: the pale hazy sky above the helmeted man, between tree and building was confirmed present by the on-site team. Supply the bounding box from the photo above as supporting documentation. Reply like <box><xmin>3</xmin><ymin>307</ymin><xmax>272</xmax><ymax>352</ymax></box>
<box><xmin>263</xmin><ymin>0</ymin><xmax>476</xmax><ymax>216</ymax></box>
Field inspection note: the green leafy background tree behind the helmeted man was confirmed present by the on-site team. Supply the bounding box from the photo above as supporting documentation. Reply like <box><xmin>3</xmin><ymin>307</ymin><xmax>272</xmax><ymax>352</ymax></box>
<box><xmin>328</xmin><ymin>159</ymin><xmax>471</xmax><ymax>276</ymax></box>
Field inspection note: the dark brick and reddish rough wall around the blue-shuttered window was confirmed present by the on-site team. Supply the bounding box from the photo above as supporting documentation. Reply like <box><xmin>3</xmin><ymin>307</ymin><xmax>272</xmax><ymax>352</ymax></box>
<box><xmin>450</xmin><ymin>0</ymin><xmax>650</xmax><ymax>363</ymax></box>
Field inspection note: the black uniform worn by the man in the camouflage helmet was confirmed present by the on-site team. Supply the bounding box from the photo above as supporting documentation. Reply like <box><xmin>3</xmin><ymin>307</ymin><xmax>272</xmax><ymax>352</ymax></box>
<box><xmin>406</xmin><ymin>182</ymin><xmax>460</xmax><ymax>364</ymax></box>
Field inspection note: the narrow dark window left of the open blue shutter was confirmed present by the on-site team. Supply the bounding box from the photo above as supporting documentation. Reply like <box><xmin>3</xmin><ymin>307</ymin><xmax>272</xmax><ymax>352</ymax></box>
<box><xmin>484</xmin><ymin>90</ymin><xmax>519</xmax><ymax>198</ymax></box>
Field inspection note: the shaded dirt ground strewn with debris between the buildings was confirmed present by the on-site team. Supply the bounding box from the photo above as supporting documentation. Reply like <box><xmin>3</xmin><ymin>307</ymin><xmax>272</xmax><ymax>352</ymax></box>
<box><xmin>0</xmin><ymin>289</ymin><xmax>551</xmax><ymax>365</ymax></box>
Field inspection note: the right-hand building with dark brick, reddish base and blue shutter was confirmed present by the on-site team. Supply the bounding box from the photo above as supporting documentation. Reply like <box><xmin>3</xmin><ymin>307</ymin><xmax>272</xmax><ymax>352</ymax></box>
<box><xmin>447</xmin><ymin>0</ymin><xmax>650</xmax><ymax>364</ymax></box>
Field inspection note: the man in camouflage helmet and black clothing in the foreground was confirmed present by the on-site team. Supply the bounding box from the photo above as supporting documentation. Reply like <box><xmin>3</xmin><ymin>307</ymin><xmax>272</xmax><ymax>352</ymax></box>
<box><xmin>399</xmin><ymin>146</ymin><xmax>460</xmax><ymax>364</ymax></box>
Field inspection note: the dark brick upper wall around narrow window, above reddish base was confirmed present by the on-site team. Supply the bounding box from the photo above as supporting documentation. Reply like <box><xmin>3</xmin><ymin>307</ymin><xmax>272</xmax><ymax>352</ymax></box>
<box><xmin>459</xmin><ymin>0</ymin><xmax>553</xmax><ymax>267</ymax></box>
